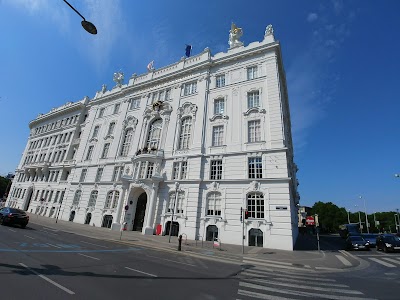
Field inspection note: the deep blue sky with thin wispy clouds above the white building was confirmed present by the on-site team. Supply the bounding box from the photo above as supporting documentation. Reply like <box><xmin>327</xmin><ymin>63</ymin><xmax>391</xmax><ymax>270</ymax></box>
<box><xmin>0</xmin><ymin>0</ymin><xmax>400</xmax><ymax>213</ymax></box>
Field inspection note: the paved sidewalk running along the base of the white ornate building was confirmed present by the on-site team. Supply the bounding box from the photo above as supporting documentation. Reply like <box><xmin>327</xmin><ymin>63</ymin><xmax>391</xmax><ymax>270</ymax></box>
<box><xmin>28</xmin><ymin>213</ymin><xmax>366</xmax><ymax>271</ymax></box>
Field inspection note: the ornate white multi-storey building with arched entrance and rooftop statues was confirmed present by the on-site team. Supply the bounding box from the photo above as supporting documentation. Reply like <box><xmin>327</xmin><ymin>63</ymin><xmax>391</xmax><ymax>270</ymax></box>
<box><xmin>7</xmin><ymin>25</ymin><xmax>299</xmax><ymax>250</ymax></box>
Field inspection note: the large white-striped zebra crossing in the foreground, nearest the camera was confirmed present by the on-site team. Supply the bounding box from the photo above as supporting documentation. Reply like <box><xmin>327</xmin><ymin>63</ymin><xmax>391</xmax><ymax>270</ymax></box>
<box><xmin>237</xmin><ymin>258</ymin><xmax>378</xmax><ymax>300</ymax></box>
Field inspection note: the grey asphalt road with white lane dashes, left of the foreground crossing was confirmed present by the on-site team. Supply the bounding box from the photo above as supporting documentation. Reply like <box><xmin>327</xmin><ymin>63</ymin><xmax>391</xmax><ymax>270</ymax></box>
<box><xmin>0</xmin><ymin>224</ymin><xmax>240</xmax><ymax>299</ymax></box>
